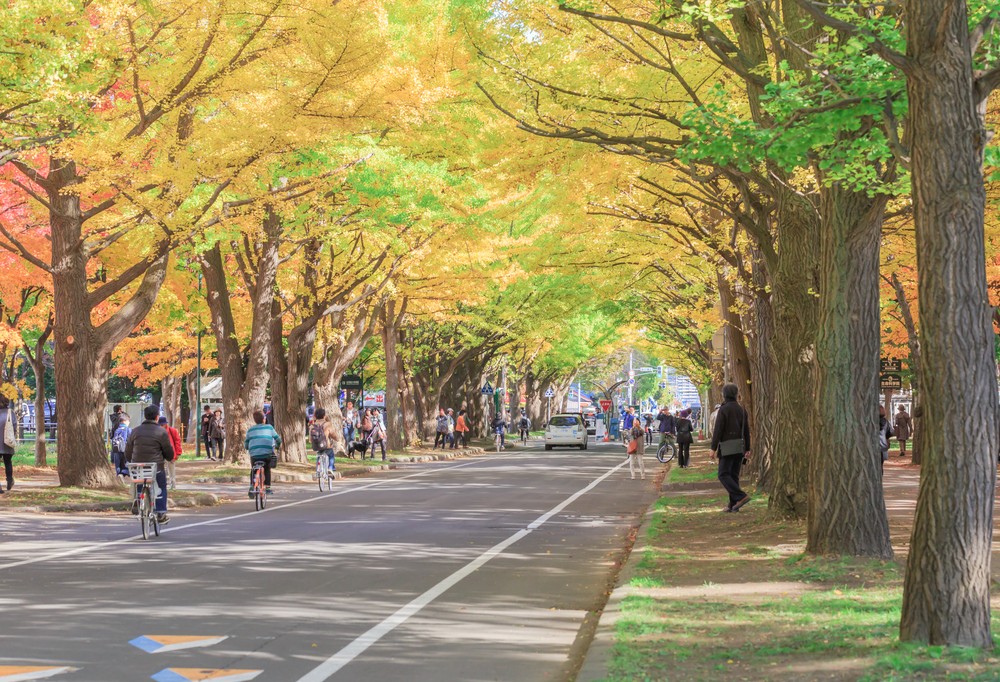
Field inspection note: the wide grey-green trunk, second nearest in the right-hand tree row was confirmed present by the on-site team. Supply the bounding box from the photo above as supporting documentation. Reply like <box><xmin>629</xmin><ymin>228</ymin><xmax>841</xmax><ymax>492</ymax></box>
<box><xmin>806</xmin><ymin>183</ymin><xmax>892</xmax><ymax>559</ymax></box>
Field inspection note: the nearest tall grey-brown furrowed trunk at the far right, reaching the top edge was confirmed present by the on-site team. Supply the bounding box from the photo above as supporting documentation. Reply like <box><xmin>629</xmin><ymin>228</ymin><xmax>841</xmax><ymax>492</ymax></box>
<box><xmin>900</xmin><ymin>0</ymin><xmax>998</xmax><ymax>648</ymax></box>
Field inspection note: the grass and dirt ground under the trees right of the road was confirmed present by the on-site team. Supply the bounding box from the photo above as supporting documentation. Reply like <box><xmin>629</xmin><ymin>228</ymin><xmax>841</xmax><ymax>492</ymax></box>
<box><xmin>577</xmin><ymin>447</ymin><xmax>1000</xmax><ymax>682</ymax></box>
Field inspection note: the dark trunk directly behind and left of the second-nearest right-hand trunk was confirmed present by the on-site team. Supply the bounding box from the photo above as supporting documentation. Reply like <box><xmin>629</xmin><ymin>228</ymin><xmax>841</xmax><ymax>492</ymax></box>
<box><xmin>768</xmin><ymin>195</ymin><xmax>818</xmax><ymax>517</ymax></box>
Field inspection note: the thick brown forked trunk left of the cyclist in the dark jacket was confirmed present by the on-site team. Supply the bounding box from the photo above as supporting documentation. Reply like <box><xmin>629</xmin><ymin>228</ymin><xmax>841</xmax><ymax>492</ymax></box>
<box><xmin>43</xmin><ymin>157</ymin><xmax>167</xmax><ymax>488</ymax></box>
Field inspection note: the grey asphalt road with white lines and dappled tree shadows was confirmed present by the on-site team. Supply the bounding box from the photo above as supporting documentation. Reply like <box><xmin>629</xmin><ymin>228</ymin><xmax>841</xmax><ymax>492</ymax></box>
<box><xmin>0</xmin><ymin>443</ymin><xmax>659</xmax><ymax>682</ymax></box>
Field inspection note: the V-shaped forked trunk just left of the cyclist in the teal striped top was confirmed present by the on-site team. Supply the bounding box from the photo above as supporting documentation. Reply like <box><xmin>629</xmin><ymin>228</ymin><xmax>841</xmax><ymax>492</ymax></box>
<box><xmin>201</xmin><ymin>211</ymin><xmax>281</xmax><ymax>462</ymax></box>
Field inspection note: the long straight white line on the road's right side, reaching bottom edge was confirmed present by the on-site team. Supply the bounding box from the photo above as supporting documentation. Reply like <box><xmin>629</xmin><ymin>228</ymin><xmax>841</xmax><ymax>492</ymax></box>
<box><xmin>298</xmin><ymin>454</ymin><xmax>625</xmax><ymax>682</ymax></box>
